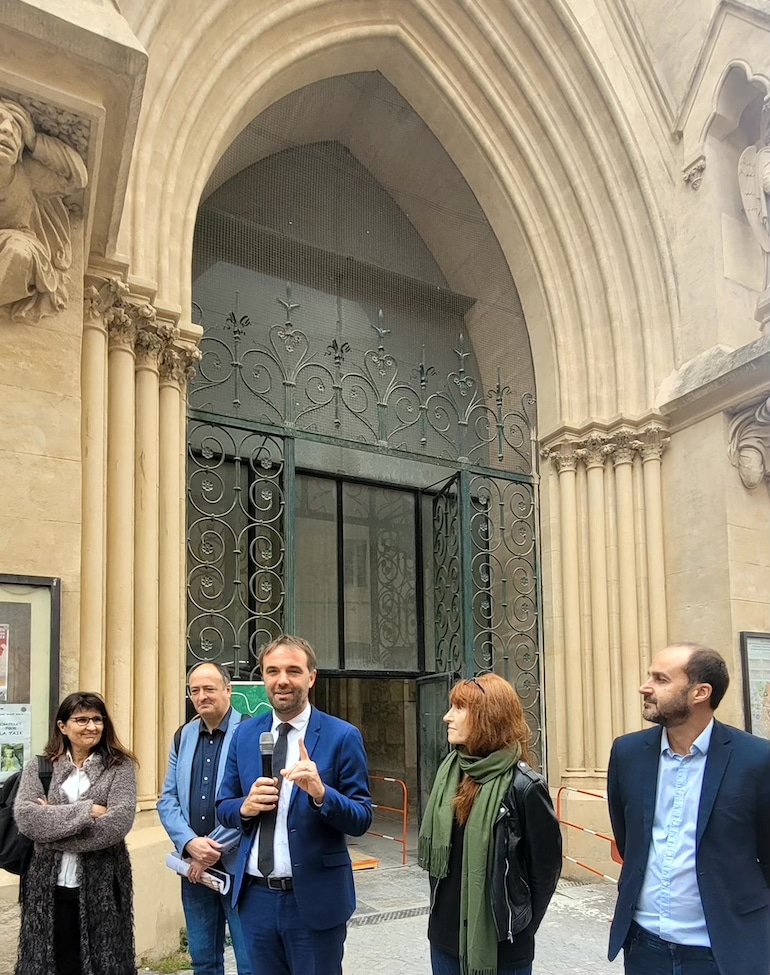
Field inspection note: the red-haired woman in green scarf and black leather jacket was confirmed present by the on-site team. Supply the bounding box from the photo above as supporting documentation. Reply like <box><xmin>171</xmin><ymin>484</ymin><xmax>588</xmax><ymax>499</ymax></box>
<box><xmin>418</xmin><ymin>674</ymin><xmax>561</xmax><ymax>975</ymax></box>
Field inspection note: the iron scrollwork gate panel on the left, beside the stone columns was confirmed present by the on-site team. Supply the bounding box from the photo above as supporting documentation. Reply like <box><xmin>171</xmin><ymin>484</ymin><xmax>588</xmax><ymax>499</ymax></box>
<box><xmin>187</xmin><ymin>421</ymin><xmax>285</xmax><ymax>677</ymax></box>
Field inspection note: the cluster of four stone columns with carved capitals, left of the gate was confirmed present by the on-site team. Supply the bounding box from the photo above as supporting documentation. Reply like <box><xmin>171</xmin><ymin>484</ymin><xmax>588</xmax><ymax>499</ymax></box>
<box><xmin>79</xmin><ymin>276</ymin><xmax>199</xmax><ymax>808</ymax></box>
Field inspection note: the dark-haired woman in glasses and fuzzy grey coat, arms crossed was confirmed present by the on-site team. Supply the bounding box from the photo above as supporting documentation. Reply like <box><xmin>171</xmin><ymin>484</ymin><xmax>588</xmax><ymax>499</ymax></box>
<box><xmin>14</xmin><ymin>692</ymin><xmax>136</xmax><ymax>975</ymax></box>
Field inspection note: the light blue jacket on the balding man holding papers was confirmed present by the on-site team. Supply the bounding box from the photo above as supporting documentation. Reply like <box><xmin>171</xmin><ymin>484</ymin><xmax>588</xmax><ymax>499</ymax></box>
<box><xmin>158</xmin><ymin>708</ymin><xmax>243</xmax><ymax>873</ymax></box>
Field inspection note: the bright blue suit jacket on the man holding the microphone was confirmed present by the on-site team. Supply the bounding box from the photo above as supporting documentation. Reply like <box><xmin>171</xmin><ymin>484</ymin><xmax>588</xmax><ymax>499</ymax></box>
<box><xmin>217</xmin><ymin>708</ymin><xmax>372</xmax><ymax>930</ymax></box>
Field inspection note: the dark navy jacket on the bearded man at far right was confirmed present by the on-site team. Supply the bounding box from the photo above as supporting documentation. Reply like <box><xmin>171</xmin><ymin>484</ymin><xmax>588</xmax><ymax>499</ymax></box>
<box><xmin>607</xmin><ymin>721</ymin><xmax>770</xmax><ymax>975</ymax></box>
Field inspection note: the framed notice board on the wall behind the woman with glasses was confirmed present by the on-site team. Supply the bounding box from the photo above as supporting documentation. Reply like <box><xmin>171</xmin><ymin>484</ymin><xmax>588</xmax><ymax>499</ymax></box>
<box><xmin>0</xmin><ymin>575</ymin><xmax>61</xmax><ymax>782</ymax></box>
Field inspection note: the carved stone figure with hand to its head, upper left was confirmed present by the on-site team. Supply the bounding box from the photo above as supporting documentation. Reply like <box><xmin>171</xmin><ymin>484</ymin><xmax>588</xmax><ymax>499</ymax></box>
<box><xmin>0</xmin><ymin>98</ymin><xmax>88</xmax><ymax>322</ymax></box>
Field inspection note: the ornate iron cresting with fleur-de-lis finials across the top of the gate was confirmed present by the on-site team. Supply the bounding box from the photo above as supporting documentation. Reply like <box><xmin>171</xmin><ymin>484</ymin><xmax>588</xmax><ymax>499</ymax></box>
<box><xmin>189</xmin><ymin>284</ymin><xmax>534</xmax><ymax>476</ymax></box>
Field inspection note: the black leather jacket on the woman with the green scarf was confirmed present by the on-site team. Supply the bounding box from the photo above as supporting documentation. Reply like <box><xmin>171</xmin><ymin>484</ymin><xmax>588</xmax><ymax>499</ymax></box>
<box><xmin>490</xmin><ymin>762</ymin><xmax>561</xmax><ymax>941</ymax></box>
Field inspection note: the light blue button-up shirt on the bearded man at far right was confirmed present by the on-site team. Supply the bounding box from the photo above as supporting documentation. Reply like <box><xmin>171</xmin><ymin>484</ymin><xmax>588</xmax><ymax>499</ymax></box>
<box><xmin>634</xmin><ymin>719</ymin><xmax>714</xmax><ymax>947</ymax></box>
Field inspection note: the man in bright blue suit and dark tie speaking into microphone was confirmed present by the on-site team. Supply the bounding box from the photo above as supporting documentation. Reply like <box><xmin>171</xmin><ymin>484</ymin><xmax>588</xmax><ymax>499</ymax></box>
<box><xmin>217</xmin><ymin>635</ymin><xmax>372</xmax><ymax>975</ymax></box>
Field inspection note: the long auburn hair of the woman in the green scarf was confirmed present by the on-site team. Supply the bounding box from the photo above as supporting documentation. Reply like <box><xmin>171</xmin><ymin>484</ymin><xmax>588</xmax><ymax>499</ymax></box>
<box><xmin>449</xmin><ymin>674</ymin><xmax>531</xmax><ymax>825</ymax></box>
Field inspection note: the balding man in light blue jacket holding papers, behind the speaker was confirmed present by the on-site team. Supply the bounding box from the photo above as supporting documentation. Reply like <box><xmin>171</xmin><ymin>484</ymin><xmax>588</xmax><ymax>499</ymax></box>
<box><xmin>158</xmin><ymin>663</ymin><xmax>251</xmax><ymax>975</ymax></box>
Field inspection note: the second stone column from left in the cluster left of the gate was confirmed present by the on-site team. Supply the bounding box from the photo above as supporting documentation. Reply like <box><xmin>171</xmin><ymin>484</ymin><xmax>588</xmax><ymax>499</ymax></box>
<box><xmin>104</xmin><ymin>307</ymin><xmax>136</xmax><ymax>744</ymax></box>
